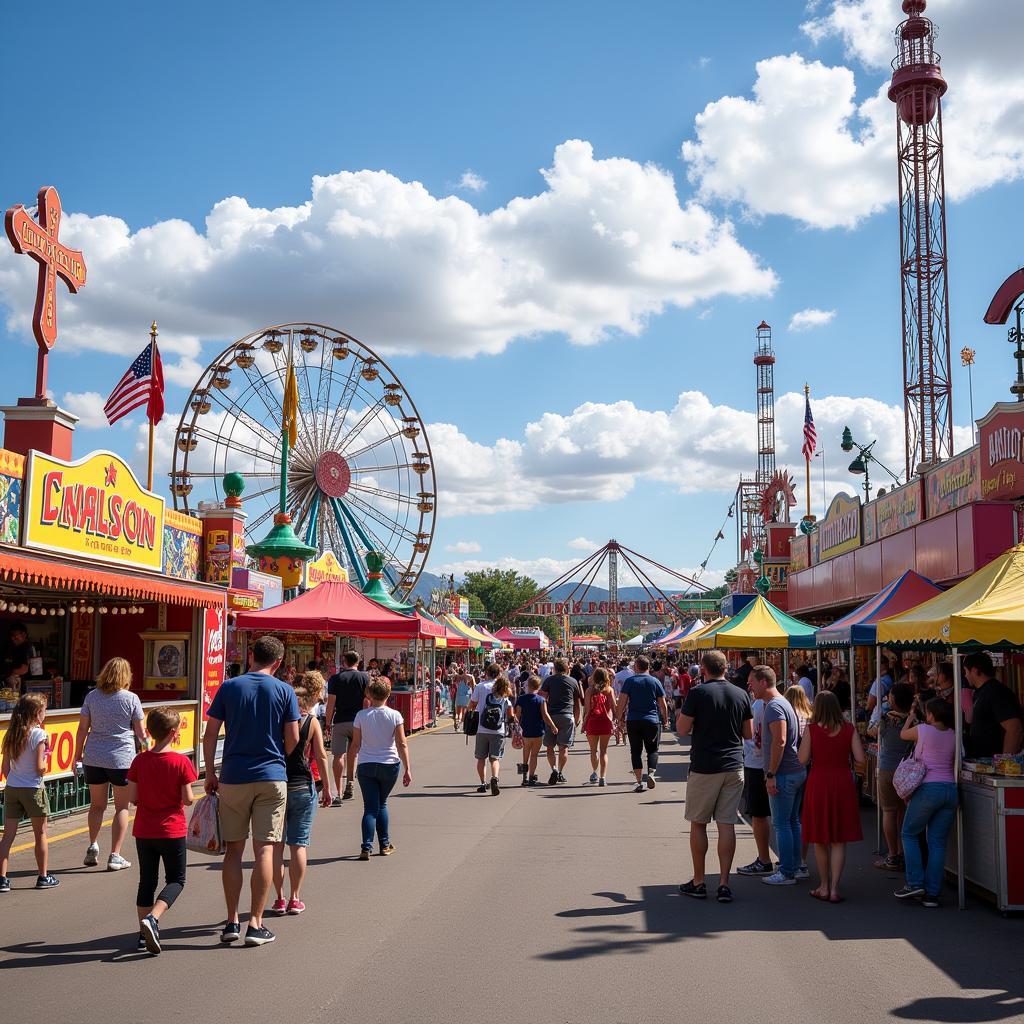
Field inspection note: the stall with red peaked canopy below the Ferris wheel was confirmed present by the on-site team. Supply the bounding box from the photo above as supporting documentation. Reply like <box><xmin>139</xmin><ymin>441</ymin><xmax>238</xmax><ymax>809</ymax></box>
<box><xmin>234</xmin><ymin>583</ymin><xmax>442</xmax><ymax>731</ymax></box>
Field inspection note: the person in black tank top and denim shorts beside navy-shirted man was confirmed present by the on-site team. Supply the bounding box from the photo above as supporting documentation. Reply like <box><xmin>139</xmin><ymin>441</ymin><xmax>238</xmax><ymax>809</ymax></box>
<box><xmin>270</xmin><ymin>672</ymin><xmax>331</xmax><ymax>915</ymax></box>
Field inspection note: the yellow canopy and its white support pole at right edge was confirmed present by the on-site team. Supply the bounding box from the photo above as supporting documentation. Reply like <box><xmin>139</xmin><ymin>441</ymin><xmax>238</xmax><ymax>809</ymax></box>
<box><xmin>878</xmin><ymin>544</ymin><xmax>1024</xmax><ymax>909</ymax></box>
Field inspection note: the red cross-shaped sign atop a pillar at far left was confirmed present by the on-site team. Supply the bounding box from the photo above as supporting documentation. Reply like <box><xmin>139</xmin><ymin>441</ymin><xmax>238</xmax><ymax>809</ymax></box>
<box><xmin>4</xmin><ymin>185</ymin><xmax>85</xmax><ymax>398</ymax></box>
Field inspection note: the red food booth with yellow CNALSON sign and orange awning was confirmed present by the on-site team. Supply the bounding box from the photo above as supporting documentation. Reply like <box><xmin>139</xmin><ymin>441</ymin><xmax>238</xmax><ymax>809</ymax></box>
<box><xmin>0</xmin><ymin>450</ymin><xmax>226</xmax><ymax>814</ymax></box>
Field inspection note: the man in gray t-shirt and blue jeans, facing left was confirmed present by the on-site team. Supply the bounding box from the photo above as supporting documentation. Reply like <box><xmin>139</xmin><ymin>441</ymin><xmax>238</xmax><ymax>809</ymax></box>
<box><xmin>750</xmin><ymin>665</ymin><xmax>807</xmax><ymax>886</ymax></box>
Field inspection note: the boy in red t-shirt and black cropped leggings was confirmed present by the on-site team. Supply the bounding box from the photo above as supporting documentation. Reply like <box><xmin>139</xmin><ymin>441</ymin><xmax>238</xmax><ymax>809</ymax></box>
<box><xmin>128</xmin><ymin>708</ymin><xmax>198</xmax><ymax>956</ymax></box>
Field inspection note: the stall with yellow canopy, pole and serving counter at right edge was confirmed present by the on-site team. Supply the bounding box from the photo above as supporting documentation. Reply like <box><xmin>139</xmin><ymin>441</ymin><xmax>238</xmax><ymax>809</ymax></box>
<box><xmin>878</xmin><ymin>545</ymin><xmax>1024</xmax><ymax>912</ymax></box>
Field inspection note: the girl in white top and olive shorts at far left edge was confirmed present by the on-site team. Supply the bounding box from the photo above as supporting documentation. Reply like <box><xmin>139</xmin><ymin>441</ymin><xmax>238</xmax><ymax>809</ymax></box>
<box><xmin>0</xmin><ymin>693</ymin><xmax>60</xmax><ymax>893</ymax></box>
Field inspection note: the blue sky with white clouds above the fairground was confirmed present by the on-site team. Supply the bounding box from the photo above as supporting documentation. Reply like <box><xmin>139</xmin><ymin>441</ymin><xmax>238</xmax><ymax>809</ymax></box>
<box><xmin>0</xmin><ymin>0</ymin><xmax>1024</xmax><ymax>589</ymax></box>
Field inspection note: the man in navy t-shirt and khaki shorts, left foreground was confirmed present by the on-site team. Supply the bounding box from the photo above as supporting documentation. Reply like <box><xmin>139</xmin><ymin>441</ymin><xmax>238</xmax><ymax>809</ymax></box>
<box><xmin>203</xmin><ymin>637</ymin><xmax>299</xmax><ymax>946</ymax></box>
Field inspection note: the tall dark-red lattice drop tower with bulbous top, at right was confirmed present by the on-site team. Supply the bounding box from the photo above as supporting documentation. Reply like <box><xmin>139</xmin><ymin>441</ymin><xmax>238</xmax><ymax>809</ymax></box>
<box><xmin>889</xmin><ymin>0</ymin><xmax>953</xmax><ymax>479</ymax></box>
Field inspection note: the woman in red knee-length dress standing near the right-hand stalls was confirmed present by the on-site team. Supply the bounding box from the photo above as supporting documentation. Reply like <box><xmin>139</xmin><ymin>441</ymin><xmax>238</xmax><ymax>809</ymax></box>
<box><xmin>800</xmin><ymin>690</ymin><xmax>864</xmax><ymax>903</ymax></box>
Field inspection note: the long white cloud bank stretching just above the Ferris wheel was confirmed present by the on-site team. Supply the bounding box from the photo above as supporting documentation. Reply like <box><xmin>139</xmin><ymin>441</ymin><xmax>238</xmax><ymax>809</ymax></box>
<box><xmin>0</xmin><ymin>140</ymin><xmax>776</xmax><ymax>366</ymax></box>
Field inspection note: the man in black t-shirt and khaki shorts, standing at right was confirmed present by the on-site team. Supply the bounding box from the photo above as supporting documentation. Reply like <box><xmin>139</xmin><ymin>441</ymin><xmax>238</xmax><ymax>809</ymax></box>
<box><xmin>676</xmin><ymin>650</ymin><xmax>753</xmax><ymax>903</ymax></box>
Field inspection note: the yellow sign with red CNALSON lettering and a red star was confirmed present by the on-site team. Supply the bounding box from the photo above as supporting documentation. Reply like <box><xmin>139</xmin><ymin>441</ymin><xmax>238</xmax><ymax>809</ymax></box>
<box><xmin>22</xmin><ymin>452</ymin><xmax>164</xmax><ymax>572</ymax></box>
